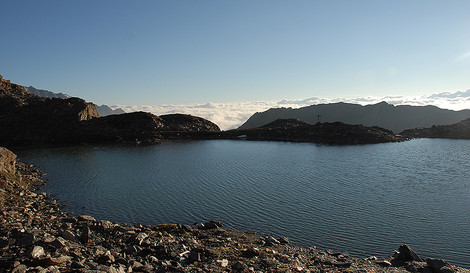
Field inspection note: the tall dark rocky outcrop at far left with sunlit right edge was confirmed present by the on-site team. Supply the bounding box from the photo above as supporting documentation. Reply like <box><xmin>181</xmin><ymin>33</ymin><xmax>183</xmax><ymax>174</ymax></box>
<box><xmin>0</xmin><ymin>74</ymin><xmax>98</xmax><ymax>146</ymax></box>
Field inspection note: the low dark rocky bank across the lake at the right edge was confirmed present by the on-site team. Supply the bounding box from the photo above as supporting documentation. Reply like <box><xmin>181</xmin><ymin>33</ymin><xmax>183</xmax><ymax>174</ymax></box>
<box><xmin>400</xmin><ymin>119</ymin><xmax>470</xmax><ymax>139</ymax></box>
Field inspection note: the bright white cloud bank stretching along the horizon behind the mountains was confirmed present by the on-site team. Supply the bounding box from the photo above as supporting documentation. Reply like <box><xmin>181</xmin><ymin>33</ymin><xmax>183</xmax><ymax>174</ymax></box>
<box><xmin>112</xmin><ymin>89</ymin><xmax>470</xmax><ymax>130</ymax></box>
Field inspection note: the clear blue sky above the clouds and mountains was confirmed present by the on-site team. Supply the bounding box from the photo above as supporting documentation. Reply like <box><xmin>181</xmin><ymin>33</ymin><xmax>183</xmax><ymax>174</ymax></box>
<box><xmin>0</xmin><ymin>0</ymin><xmax>470</xmax><ymax>105</ymax></box>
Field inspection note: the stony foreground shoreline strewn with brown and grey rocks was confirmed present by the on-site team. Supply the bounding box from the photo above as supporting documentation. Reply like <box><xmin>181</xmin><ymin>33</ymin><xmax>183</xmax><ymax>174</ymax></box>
<box><xmin>0</xmin><ymin>148</ymin><xmax>470</xmax><ymax>273</ymax></box>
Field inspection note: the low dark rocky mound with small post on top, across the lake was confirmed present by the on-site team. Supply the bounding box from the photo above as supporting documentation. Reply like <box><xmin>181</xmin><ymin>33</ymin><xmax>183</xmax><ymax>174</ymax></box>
<box><xmin>218</xmin><ymin>119</ymin><xmax>406</xmax><ymax>145</ymax></box>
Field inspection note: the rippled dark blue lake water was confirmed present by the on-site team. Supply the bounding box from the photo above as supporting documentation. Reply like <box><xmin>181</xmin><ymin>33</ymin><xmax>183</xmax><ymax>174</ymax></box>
<box><xmin>18</xmin><ymin>139</ymin><xmax>470</xmax><ymax>267</ymax></box>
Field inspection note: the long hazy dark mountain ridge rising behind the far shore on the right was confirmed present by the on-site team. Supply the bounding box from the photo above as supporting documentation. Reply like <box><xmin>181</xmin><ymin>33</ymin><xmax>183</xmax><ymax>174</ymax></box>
<box><xmin>238</xmin><ymin>102</ymin><xmax>470</xmax><ymax>133</ymax></box>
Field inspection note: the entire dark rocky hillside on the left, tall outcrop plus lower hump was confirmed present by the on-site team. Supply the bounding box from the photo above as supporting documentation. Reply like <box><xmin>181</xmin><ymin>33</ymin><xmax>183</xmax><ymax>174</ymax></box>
<box><xmin>0</xmin><ymin>74</ymin><xmax>220</xmax><ymax>146</ymax></box>
